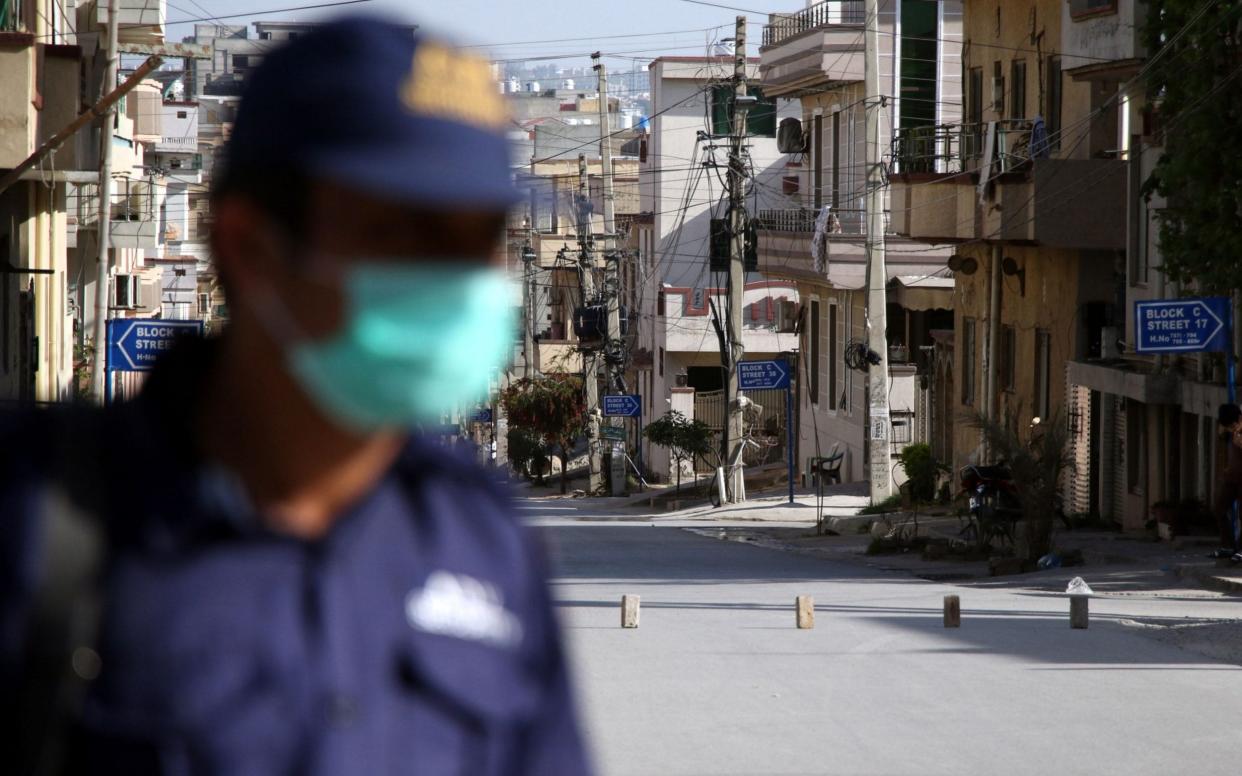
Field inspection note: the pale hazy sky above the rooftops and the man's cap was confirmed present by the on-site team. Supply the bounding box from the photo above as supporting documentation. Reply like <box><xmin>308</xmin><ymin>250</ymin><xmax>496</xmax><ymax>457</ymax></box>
<box><xmin>168</xmin><ymin>0</ymin><xmax>805</xmax><ymax>65</ymax></box>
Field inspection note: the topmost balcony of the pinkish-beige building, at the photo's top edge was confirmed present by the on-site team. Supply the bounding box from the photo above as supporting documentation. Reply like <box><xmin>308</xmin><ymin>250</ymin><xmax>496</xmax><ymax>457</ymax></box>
<box><xmin>759</xmin><ymin>0</ymin><xmax>864</xmax><ymax>97</ymax></box>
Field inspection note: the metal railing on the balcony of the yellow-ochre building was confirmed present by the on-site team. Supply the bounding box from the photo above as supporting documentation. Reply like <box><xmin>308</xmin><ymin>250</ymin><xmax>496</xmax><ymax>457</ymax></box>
<box><xmin>893</xmin><ymin>119</ymin><xmax>1038</xmax><ymax>175</ymax></box>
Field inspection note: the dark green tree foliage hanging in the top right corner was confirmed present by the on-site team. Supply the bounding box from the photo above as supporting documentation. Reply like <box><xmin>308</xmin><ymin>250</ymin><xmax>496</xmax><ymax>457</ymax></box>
<box><xmin>1143</xmin><ymin>0</ymin><xmax>1242</xmax><ymax>293</ymax></box>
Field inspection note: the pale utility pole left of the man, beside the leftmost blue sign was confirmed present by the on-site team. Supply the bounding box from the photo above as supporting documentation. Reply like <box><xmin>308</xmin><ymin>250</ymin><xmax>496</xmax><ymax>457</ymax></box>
<box><xmin>91</xmin><ymin>0</ymin><xmax>120</xmax><ymax>404</ymax></box>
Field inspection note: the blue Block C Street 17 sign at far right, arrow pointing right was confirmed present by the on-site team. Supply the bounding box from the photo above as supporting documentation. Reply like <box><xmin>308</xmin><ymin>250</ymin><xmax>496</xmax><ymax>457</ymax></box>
<box><xmin>1134</xmin><ymin>297</ymin><xmax>1230</xmax><ymax>353</ymax></box>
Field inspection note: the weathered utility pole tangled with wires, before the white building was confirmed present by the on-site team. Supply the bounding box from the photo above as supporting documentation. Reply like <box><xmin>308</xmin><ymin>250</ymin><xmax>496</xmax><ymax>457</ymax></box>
<box><xmin>725</xmin><ymin>16</ymin><xmax>754</xmax><ymax>503</ymax></box>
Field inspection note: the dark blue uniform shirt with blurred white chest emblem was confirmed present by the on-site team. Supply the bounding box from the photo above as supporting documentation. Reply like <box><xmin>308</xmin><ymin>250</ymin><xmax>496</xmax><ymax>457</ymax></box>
<box><xmin>0</xmin><ymin>343</ymin><xmax>587</xmax><ymax>776</ymax></box>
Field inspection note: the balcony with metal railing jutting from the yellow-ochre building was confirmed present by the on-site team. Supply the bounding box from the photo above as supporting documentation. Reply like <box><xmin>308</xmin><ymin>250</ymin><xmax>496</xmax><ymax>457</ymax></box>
<box><xmin>891</xmin><ymin>120</ymin><xmax>1126</xmax><ymax>250</ymax></box>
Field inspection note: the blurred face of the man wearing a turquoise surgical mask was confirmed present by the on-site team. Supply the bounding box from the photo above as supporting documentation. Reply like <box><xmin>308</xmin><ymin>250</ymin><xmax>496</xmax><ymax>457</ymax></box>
<box><xmin>215</xmin><ymin>177</ymin><xmax>514</xmax><ymax>432</ymax></box>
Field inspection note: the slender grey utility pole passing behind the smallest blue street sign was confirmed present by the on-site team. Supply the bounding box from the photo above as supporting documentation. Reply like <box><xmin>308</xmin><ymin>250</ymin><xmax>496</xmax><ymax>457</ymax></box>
<box><xmin>591</xmin><ymin>51</ymin><xmax>625</xmax><ymax>495</ymax></box>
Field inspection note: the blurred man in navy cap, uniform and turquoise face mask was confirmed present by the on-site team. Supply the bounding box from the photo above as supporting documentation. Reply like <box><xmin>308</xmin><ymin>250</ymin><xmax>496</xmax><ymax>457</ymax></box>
<box><xmin>0</xmin><ymin>19</ymin><xmax>587</xmax><ymax>776</ymax></box>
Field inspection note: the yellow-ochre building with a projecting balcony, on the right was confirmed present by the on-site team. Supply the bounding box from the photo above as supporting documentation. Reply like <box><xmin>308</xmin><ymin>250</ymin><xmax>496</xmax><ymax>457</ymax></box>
<box><xmin>892</xmin><ymin>0</ymin><xmax>1143</xmax><ymax>528</ymax></box>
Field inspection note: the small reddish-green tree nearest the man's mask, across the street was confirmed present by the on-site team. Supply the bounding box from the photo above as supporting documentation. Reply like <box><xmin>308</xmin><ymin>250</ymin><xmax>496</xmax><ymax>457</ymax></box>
<box><xmin>501</xmin><ymin>375</ymin><xmax>586</xmax><ymax>493</ymax></box>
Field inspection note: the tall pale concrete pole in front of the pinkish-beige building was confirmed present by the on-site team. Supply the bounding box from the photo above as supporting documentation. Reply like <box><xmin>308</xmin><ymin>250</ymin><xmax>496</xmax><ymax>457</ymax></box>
<box><xmin>863</xmin><ymin>0</ymin><xmax>893</xmax><ymax>504</ymax></box>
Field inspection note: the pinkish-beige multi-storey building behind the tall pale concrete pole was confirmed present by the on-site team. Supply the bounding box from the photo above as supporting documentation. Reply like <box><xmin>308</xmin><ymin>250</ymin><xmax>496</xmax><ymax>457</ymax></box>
<box><xmin>758</xmin><ymin>0</ymin><xmax>961</xmax><ymax>482</ymax></box>
